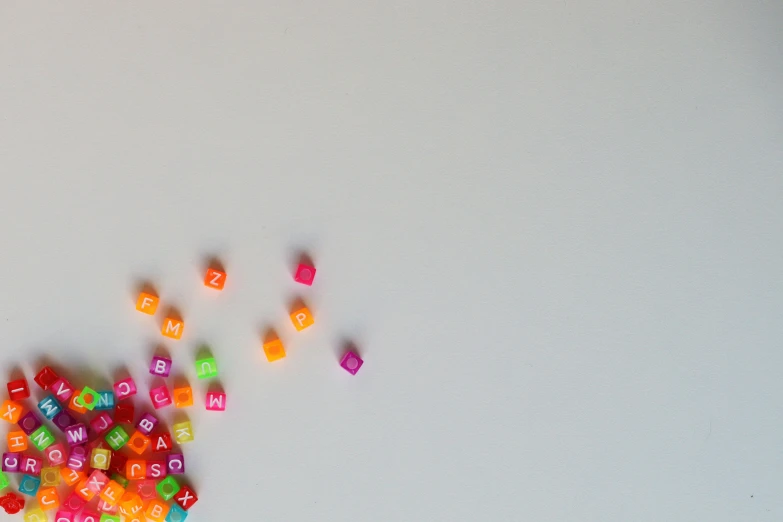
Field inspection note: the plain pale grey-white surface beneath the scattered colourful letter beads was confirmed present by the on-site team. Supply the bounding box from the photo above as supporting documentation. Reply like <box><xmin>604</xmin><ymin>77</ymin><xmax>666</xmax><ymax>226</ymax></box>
<box><xmin>0</xmin><ymin>0</ymin><xmax>783</xmax><ymax>522</ymax></box>
